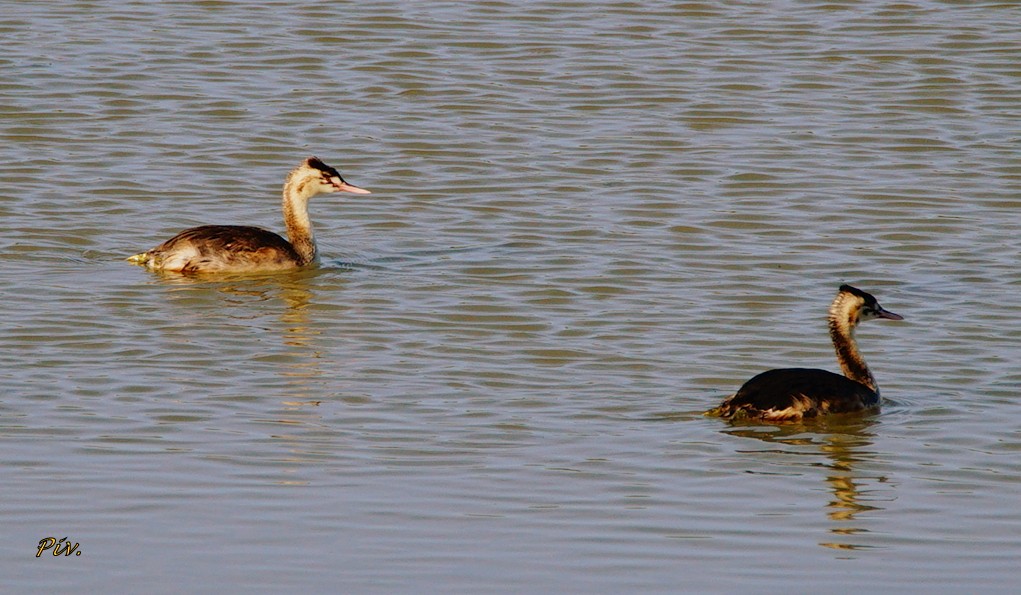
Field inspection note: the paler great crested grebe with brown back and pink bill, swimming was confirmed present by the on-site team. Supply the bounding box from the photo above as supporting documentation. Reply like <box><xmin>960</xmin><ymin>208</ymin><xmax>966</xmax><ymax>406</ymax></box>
<box><xmin>128</xmin><ymin>157</ymin><xmax>370</xmax><ymax>274</ymax></box>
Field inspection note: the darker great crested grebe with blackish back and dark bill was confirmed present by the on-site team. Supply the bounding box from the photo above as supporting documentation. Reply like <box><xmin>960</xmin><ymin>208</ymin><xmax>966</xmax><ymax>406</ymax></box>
<box><xmin>706</xmin><ymin>285</ymin><xmax>904</xmax><ymax>422</ymax></box>
